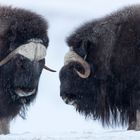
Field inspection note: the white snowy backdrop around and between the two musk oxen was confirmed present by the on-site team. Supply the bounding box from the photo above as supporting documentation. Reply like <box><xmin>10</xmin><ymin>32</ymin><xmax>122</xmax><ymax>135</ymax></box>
<box><xmin>0</xmin><ymin>0</ymin><xmax>140</xmax><ymax>140</ymax></box>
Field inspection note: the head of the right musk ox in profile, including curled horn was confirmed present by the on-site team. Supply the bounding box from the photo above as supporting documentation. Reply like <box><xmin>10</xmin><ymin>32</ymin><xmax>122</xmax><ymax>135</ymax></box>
<box><xmin>60</xmin><ymin>41</ymin><xmax>103</xmax><ymax>116</ymax></box>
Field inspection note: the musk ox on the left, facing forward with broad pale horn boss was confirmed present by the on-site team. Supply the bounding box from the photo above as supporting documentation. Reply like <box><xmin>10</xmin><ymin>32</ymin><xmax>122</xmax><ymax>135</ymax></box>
<box><xmin>0</xmin><ymin>6</ymin><xmax>55</xmax><ymax>134</ymax></box>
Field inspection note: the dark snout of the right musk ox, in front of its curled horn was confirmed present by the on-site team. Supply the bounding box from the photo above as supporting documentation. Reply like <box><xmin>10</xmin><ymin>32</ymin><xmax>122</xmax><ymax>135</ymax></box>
<box><xmin>59</xmin><ymin>63</ymin><xmax>86</xmax><ymax>105</ymax></box>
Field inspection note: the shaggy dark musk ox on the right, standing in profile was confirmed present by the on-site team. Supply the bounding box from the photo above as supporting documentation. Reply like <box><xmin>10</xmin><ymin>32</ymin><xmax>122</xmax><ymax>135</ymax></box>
<box><xmin>60</xmin><ymin>5</ymin><xmax>140</xmax><ymax>130</ymax></box>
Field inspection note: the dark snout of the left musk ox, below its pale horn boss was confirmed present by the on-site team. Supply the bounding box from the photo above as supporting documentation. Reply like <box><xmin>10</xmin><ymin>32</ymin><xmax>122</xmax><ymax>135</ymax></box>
<box><xmin>14</xmin><ymin>56</ymin><xmax>44</xmax><ymax>97</ymax></box>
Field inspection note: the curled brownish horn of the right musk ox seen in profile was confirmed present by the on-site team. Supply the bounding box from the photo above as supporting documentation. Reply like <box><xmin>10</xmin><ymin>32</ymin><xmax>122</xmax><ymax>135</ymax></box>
<box><xmin>64</xmin><ymin>50</ymin><xmax>91</xmax><ymax>78</ymax></box>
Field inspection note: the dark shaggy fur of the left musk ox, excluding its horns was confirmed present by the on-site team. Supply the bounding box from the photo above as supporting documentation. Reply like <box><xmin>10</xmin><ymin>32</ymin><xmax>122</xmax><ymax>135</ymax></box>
<box><xmin>0</xmin><ymin>7</ymin><xmax>48</xmax><ymax>119</ymax></box>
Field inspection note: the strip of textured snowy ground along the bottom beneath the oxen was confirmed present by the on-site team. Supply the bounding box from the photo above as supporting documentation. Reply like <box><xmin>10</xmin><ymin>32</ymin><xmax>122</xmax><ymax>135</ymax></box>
<box><xmin>0</xmin><ymin>130</ymin><xmax>140</xmax><ymax>140</ymax></box>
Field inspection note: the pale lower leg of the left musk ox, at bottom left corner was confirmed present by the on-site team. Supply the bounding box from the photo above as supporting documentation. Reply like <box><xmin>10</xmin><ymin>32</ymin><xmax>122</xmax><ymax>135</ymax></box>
<box><xmin>0</xmin><ymin>119</ymin><xmax>10</xmax><ymax>135</ymax></box>
